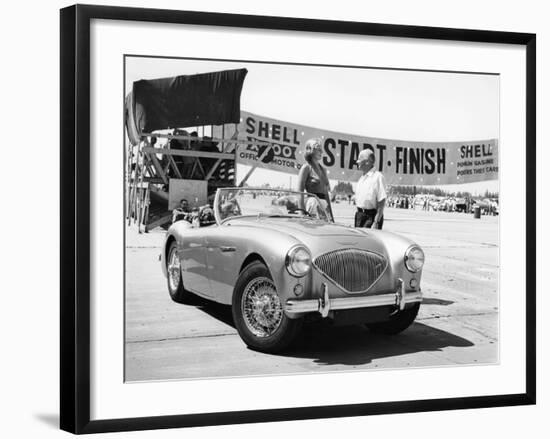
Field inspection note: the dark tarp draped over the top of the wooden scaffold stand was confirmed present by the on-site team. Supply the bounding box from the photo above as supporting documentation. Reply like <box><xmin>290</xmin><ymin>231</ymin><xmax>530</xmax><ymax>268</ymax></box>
<box><xmin>126</xmin><ymin>69</ymin><xmax>247</xmax><ymax>144</ymax></box>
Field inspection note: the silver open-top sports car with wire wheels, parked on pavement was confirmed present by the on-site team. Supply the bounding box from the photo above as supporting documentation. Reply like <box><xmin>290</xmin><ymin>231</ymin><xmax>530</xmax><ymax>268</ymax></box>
<box><xmin>161</xmin><ymin>188</ymin><xmax>424</xmax><ymax>352</ymax></box>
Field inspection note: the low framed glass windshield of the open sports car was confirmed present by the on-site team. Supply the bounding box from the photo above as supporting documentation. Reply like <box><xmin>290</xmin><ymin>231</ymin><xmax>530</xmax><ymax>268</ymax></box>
<box><xmin>215</xmin><ymin>188</ymin><xmax>329</xmax><ymax>221</ymax></box>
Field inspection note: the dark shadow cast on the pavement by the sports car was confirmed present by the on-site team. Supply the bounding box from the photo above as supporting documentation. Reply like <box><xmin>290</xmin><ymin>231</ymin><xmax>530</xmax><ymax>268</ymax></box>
<box><xmin>188</xmin><ymin>296</ymin><xmax>474</xmax><ymax>366</ymax></box>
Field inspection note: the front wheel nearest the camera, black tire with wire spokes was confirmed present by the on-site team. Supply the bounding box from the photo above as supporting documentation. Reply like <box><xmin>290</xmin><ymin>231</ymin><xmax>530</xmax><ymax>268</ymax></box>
<box><xmin>232</xmin><ymin>261</ymin><xmax>302</xmax><ymax>353</ymax></box>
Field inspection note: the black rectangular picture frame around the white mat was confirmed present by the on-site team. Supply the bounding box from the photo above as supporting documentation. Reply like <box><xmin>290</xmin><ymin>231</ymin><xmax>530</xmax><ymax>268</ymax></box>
<box><xmin>60</xmin><ymin>5</ymin><xmax>536</xmax><ymax>433</ymax></box>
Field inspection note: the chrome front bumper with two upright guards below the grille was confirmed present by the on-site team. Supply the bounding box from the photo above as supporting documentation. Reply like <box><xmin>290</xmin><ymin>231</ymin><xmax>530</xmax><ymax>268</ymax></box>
<box><xmin>285</xmin><ymin>279</ymin><xmax>422</xmax><ymax>317</ymax></box>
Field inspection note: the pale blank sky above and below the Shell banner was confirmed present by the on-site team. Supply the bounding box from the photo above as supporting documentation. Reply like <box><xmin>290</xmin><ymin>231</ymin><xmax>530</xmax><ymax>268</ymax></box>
<box><xmin>125</xmin><ymin>57</ymin><xmax>499</xmax><ymax>194</ymax></box>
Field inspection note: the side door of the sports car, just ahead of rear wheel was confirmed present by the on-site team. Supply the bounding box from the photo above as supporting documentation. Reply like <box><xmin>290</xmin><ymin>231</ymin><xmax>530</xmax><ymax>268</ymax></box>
<box><xmin>179</xmin><ymin>228</ymin><xmax>212</xmax><ymax>297</ymax></box>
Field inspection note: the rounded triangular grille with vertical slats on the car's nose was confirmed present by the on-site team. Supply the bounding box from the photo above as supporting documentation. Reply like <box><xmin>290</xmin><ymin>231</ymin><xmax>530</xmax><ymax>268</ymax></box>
<box><xmin>314</xmin><ymin>249</ymin><xmax>388</xmax><ymax>293</ymax></box>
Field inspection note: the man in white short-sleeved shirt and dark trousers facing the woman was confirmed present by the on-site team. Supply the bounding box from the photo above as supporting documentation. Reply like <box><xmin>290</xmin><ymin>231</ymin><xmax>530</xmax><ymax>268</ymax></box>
<box><xmin>355</xmin><ymin>149</ymin><xmax>386</xmax><ymax>229</ymax></box>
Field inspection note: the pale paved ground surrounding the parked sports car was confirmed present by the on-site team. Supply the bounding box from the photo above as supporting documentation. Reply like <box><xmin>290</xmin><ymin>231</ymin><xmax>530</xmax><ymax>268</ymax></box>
<box><xmin>126</xmin><ymin>204</ymin><xmax>498</xmax><ymax>381</ymax></box>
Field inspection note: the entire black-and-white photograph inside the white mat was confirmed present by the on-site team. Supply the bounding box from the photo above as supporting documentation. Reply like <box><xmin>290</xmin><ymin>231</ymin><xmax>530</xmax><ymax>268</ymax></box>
<box><xmin>126</xmin><ymin>54</ymin><xmax>501</xmax><ymax>383</ymax></box>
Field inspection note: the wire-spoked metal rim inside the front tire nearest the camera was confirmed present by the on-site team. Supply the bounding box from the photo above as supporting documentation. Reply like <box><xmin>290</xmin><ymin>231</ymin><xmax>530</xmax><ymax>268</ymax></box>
<box><xmin>241</xmin><ymin>277</ymin><xmax>283</xmax><ymax>338</ymax></box>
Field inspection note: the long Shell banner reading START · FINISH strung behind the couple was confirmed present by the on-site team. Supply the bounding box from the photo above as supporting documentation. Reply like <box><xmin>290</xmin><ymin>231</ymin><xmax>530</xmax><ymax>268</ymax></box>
<box><xmin>237</xmin><ymin>111</ymin><xmax>498</xmax><ymax>186</ymax></box>
